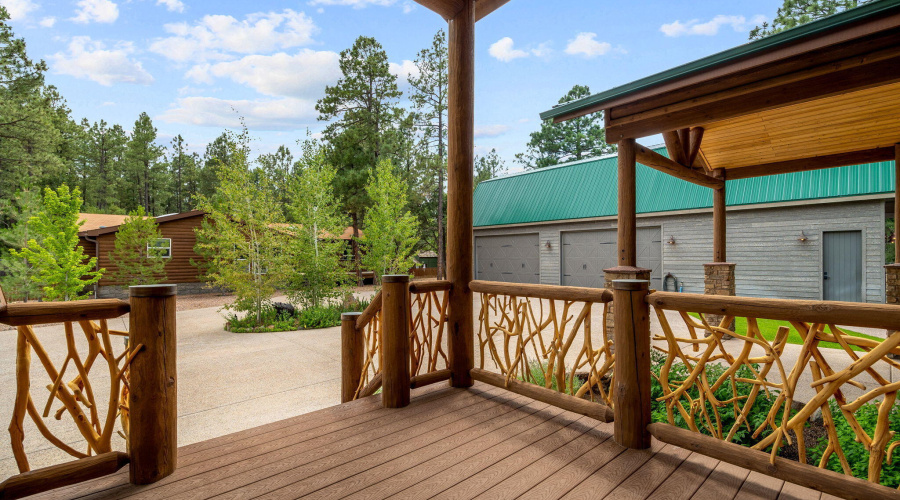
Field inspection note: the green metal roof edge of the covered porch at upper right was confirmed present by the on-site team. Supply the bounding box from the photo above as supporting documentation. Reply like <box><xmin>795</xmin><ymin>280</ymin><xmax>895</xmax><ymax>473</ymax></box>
<box><xmin>541</xmin><ymin>0</ymin><xmax>900</xmax><ymax>120</ymax></box>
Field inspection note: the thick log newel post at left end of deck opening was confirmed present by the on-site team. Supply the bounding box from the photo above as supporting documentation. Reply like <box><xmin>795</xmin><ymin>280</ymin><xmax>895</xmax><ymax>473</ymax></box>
<box><xmin>128</xmin><ymin>285</ymin><xmax>178</xmax><ymax>484</ymax></box>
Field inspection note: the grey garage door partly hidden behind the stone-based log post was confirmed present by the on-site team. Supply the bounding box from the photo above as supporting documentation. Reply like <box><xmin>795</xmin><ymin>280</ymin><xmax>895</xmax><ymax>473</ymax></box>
<box><xmin>560</xmin><ymin>227</ymin><xmax>662</xmax><ymax>290</ymax></box>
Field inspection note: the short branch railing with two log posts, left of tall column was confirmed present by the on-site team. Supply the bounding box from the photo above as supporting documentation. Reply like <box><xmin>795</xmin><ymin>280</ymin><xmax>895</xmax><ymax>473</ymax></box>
<box><xmin>341</xmin><ymin>275</ymin><xmax>450</xmax><ymax>406</ymax></box>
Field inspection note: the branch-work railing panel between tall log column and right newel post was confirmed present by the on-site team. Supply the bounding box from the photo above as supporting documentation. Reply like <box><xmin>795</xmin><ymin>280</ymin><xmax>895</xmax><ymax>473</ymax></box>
<box><xmin>469</xmin><ymin>281</ymin><xmax>614</xmax><ymax>422</ymax></box>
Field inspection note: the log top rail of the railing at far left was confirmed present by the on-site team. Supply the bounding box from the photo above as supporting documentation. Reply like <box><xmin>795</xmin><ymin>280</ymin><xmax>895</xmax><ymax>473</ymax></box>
<box><xmin>0</xmin><ymin>299</ymin><xmax>131</xmax><ymax>326</ymax></box>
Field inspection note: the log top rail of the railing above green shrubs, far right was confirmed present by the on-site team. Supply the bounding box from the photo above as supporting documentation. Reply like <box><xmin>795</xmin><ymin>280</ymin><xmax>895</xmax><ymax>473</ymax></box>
<box><xmin>647</xmin><ymin>292</ymin><xmax>900</xmax><ymax>330</ymax></box>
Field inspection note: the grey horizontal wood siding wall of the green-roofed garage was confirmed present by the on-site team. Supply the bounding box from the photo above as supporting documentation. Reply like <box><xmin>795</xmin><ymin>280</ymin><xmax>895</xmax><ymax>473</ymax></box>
<box><xmin>475</xmin><ymin>200</ymin><xmax>885</xmax><ymax>303</ymax></box>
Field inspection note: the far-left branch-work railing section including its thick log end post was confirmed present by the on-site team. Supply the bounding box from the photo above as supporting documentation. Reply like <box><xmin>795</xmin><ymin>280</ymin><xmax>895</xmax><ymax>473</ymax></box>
<box><xmin>0</xmin><ymin>285</ymin><xmax>176</xmax><ymax>499</ymax></box>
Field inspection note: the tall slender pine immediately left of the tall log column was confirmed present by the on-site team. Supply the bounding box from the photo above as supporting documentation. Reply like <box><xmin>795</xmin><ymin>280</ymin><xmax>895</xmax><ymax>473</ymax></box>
<box><xmin>409</xmin><ymin>30</ymin><xmax>449</xmax><ymax>279</ymax></box>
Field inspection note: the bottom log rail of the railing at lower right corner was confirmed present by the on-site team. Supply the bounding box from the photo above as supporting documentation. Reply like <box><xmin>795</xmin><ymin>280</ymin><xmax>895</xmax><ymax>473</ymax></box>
<box><xmin>648</xmin><ymin>423</ymin><xmax>897</xmax><ymax>500</ymax></box>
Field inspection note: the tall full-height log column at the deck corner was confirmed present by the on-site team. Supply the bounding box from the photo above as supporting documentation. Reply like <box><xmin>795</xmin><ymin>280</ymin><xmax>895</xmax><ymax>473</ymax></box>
<box><xmin>447</xmin><ymin>0</ymin><xmax>475</xmax><ymax>387</ymax></box>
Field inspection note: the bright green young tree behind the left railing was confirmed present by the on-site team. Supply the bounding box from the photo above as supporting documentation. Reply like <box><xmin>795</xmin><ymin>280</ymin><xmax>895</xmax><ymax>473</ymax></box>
<box><xmin>11</xmin><ymin>184</ymin><xmax>104</xmax><ymax>300</ymax></box>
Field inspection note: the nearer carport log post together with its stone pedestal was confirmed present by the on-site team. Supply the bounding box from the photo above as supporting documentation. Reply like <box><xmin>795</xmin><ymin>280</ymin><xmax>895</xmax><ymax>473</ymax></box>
<box><xmin>603</xmin><ymin>139</ymin><xmax>650</xmax><ymax>351</ymax></box>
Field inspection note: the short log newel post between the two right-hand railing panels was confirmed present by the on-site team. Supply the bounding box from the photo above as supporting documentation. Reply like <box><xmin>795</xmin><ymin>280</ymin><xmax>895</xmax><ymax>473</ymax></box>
<box><xmin>613</xmin><ymin>280</ymin><xmax>651</xmax><ymax>449</ymax></box>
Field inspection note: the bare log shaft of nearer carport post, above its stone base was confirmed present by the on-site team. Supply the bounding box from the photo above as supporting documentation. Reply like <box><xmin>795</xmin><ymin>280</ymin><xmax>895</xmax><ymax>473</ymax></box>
<box><xmin>616</xmin><ymin>139</ymin><xmax>636</xmax><ymax>267</ymax></box>
